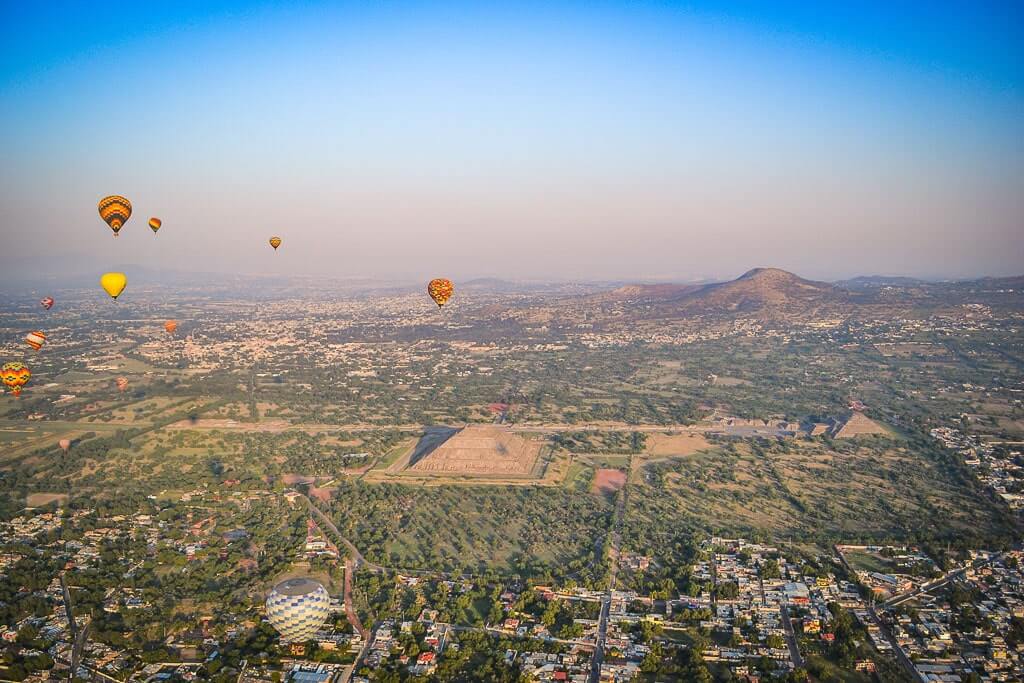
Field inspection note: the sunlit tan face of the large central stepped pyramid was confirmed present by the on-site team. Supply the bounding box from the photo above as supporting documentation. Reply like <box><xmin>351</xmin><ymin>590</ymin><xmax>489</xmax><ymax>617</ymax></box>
<box><xmin>410</xmin><ymin>425</ymin><xmax>541</xmax><ymax>476</ymax></box>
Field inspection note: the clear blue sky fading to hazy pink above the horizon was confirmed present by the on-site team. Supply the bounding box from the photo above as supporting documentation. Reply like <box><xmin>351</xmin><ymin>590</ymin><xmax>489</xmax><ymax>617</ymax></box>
<box><xmin>0</xmin><ymin>2</ymin><xmax>1024</xmax><ymax>280</ymax></box>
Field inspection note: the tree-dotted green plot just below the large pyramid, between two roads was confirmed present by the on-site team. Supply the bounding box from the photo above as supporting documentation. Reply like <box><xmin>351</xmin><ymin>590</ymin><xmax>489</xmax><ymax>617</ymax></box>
<box><xmin>324</xmin><ymin>480</ymin><xmax>612</xmax><ymax>585</ymax></box>
